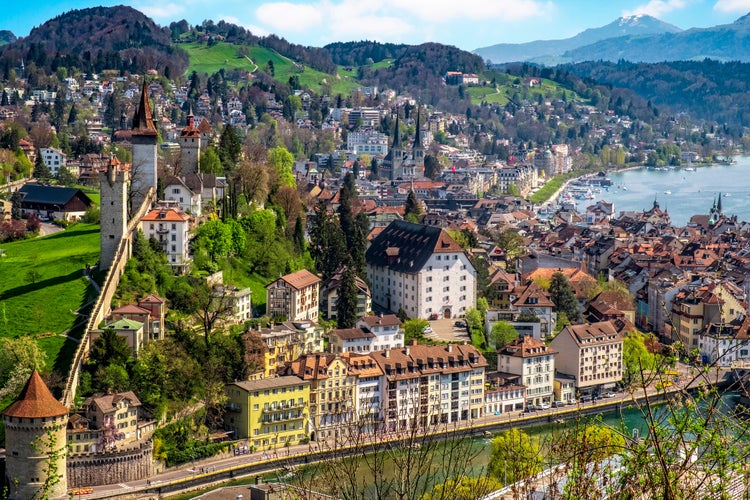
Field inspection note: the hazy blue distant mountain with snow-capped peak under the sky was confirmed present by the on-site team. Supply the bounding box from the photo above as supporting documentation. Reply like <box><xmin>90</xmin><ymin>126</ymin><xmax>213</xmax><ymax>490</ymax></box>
<box><xmin>474</xmin><ymin>15</ymin><xmax>682</xmax><ymax>64</ymax></box>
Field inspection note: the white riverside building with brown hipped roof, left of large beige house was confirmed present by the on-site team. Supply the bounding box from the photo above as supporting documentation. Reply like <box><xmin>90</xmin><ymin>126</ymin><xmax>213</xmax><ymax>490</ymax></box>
<box><xmin>497</xmin><ymin>335</ymin><xmax>557</xmax><ymax>405</ymax></box>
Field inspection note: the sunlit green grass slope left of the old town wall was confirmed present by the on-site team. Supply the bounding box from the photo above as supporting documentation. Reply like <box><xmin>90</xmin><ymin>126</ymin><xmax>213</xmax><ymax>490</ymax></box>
<box><xmin>0</xmin><ymin>223</ymin><xmax>99</xmax><ymax>374</ymax></box>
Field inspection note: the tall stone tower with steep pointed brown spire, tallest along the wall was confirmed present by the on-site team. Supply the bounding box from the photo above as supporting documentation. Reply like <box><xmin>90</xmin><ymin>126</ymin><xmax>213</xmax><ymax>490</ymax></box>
<box><xmin>130</xmin><ymin>79</ymin><xmax>158</xmax><ymax>213</ymax></box>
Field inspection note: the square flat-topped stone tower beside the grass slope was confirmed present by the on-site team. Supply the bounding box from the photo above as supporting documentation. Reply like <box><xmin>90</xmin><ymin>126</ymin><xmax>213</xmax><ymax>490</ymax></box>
<box><xmin>99</xmin><ymin>156</ymin><xmax>130</xmax><ymax>270</ymax></box>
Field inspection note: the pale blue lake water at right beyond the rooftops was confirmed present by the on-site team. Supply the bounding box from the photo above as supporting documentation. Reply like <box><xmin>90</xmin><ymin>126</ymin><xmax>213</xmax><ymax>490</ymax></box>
<box><xmin>576</xmin><ymin>156</ymin><xmax>750</xmax><ymax>226</ymax></box>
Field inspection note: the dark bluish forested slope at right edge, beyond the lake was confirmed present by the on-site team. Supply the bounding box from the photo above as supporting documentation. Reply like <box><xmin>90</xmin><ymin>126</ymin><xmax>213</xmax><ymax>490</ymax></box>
<box><xmin>561</xmin><ymin>59</ymin><xmax>750</xmax><ymax>127</ymax></box>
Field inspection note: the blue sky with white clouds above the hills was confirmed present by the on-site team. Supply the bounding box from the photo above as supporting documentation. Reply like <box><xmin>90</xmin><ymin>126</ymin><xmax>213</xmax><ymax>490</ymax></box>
<box><xmin>0</xmin><ymin>0</ymin><xmax>750</xmax><ymax>50</ymax></box>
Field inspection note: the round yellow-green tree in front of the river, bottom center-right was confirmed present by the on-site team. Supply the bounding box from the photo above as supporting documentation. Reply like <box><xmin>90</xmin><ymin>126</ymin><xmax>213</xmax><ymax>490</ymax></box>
<box><xmin>489</xmin><ymin>429</ymin><xmax>543</xmax><ymax>484</ymax></box>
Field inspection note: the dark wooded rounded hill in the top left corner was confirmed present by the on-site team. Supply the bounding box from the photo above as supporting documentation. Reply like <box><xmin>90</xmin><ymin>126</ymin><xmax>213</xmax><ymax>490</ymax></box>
<box><xmin>0</xmin><ymin>6</ymin><xmax>188</xmax><ymax>81</ymax></box>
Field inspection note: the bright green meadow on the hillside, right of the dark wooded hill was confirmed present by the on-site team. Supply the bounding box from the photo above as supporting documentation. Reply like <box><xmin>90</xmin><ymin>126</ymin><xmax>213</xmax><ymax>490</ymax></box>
<box><xmin>180</xmin><ymin>42</ymin><xmax>359</xmax><ymax>94</ymax></box>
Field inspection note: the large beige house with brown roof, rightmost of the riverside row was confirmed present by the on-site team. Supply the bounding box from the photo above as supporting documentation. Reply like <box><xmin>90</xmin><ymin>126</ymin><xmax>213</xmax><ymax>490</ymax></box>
<box><xmin>550</xmin><ymin>321</ymin><xmax>623</xmax><ymax>395</ymax></box>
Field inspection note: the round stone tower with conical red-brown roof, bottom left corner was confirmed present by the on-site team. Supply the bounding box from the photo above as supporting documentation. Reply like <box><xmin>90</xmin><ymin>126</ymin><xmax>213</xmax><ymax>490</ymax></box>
<box><xmin>3</xmin><ymin>370</ymin><xmax>68</xmax><ymax>500</ymax></box>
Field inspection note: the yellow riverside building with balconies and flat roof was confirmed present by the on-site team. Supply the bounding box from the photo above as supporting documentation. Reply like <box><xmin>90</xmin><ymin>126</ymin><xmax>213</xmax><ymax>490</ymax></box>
<box><xmin>224</xmin><ymin>376</ymin><xmax>310</xmax><ymax>450</ymax></box>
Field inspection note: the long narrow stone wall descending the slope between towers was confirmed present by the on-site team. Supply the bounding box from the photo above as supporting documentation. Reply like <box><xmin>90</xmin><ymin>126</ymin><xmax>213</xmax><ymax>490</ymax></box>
<box><xmin>62</xmin><ymin>188</ymin><xmax>156</xmax><ymax>408</ymax></box>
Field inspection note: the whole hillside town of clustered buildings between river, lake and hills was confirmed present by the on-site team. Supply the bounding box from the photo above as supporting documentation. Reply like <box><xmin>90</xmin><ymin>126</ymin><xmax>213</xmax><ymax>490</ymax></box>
<box><xmin>0</xmin><ymin>7</ymin><xmax>750</xmax><ymax>498</ymax></box>
